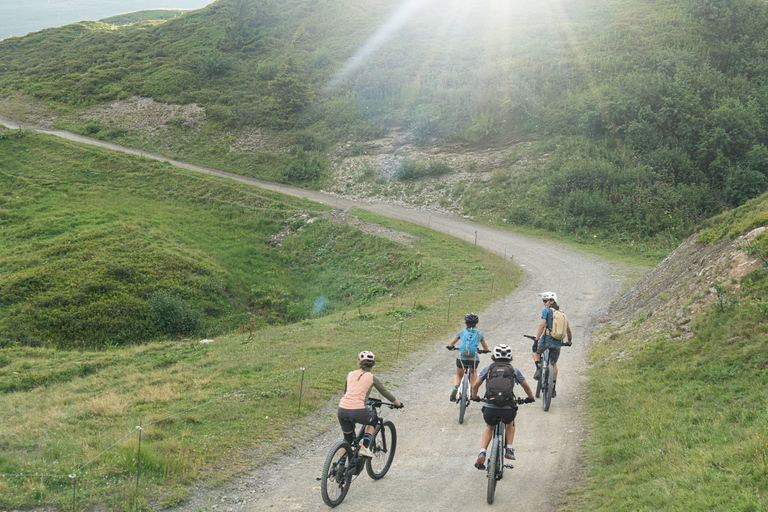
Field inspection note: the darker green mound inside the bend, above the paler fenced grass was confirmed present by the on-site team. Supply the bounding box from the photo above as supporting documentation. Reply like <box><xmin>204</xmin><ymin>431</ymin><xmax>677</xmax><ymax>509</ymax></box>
<box><xmin>0</xmin><ymin>131</ymin><xmax>460</xmax><ymax>348</ymax></box>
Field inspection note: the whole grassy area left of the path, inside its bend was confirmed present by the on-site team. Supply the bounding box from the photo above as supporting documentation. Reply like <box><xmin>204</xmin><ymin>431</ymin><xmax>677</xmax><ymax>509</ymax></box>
<box><xmin>0</xmin><ymin>131</ymin><xmax>521</xmax><ymax>511</ymax></box>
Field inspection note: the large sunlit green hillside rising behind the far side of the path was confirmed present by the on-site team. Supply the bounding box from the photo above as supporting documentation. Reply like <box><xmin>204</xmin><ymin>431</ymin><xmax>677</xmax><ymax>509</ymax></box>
<box><xmin>0</xmin><ymin>0</ymin><xmax>768</xmax><ymax>248</ymax></box>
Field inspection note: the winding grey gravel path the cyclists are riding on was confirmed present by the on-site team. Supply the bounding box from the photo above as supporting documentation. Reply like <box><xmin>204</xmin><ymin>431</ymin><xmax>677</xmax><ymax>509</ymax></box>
<box><xmin>0</xmin><ymin>117</ymin><xmax>626</xmax><ymax>512</ymax></box>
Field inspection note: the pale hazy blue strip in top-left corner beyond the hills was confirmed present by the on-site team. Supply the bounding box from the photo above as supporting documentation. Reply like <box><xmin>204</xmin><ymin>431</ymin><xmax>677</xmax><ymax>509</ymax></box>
<box><xmin>0</xmin><ymin>0</ymin><xmax>214</xmax><ymax>39</ymax></box>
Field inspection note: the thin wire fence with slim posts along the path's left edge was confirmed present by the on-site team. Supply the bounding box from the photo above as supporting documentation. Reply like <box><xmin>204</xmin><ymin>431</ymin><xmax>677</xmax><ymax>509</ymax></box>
<box><xmin>0</xmin><ymin>258</ymin><xmax>514</xmax><ymax>511</ymax></box>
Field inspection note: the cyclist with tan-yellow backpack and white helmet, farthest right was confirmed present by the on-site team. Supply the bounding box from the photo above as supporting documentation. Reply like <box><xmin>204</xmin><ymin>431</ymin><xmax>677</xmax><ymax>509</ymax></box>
<box><xmin>532</xmin><ymin>292</ymin><xmax>573</xmax><ymax>398</ymax></box>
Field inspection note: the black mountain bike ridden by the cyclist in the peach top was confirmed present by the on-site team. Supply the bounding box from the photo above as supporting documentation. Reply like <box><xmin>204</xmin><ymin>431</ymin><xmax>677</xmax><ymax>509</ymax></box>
<box><xmin>318</xmin><ymin>398</ymin><xmax>397</xmax><ymax>507</ymax></box>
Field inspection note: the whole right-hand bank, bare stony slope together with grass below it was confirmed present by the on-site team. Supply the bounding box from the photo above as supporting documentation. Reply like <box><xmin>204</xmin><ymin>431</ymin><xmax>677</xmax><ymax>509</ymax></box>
<box><xmin>564</xmin><ymin>194</ymin><xmax>768</xmax><ymax>511</ymax></box>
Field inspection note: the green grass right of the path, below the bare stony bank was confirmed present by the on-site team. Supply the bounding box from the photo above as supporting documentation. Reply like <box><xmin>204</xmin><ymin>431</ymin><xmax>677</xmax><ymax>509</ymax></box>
<box><xmin>563</xmin><ymin>269</ymin><xmax>768</xmax><ymax>512</ymax></box>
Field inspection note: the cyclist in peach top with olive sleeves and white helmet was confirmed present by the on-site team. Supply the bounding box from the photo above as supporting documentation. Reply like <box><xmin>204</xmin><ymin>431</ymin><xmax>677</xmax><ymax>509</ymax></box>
<box><xmin>337</xmin><ymin>350</ymin><xmax>403</xmax><ymax>457</ymax></box>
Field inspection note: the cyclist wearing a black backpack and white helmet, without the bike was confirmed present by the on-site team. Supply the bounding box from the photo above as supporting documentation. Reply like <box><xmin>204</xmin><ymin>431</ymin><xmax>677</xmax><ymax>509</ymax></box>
<box><xmin>472</xmin><ymin>345</ymin><xmax>535</xmax><ymax>469</ymax></box>
